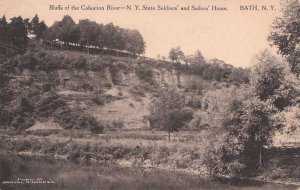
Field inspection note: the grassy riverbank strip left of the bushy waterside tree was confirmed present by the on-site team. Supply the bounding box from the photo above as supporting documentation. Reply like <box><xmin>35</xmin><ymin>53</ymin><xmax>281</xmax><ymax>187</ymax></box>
<box><xmin>0</xmin><ymin>131</ymin><xmax>207</xmax><ymax>176</ymax></box>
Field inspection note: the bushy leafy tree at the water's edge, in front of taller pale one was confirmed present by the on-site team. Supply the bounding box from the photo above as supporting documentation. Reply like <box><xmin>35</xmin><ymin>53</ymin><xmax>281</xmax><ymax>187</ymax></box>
<box><xmin>203</xmin><ymin>85</ymin><xmax>281</xmax><ymax>177</ymax></box>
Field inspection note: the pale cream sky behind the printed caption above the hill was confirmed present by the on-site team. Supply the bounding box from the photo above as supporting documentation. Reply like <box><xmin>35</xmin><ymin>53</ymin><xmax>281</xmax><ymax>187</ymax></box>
<box><xmin>0</xmin><ymin>0</ymin><xmax>280</xmax><ymax>67</ymax></box>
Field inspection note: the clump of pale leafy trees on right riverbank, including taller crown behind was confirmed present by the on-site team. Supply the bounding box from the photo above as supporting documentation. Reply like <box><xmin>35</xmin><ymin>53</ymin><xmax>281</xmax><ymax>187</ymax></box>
<box><xmin>202</xmin><ymin>51</ymin><xmax>300</xmax><ymax>176</ymax></box>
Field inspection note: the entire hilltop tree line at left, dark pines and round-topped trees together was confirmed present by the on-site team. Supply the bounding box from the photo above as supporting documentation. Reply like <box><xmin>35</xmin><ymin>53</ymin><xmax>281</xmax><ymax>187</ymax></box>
<box><xmin>0</xmin><ymin>15</ymin><xmax>145</xmax><ymax>54</ymax></box>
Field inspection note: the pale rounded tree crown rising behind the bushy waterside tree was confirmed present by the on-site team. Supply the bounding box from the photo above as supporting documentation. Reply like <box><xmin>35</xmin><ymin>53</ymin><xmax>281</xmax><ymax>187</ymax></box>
<box><xmin>251</xmin><ymin>50</ymin><xmax>300</xmax><ymax>111</ymax></box>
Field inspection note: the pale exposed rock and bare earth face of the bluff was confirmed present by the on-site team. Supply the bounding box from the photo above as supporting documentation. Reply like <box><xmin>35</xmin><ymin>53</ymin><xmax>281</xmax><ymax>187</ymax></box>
<box><xmin>13</xmin><ymin>60</ymin><xmax>208</xmax><ymax>128</ymax></box>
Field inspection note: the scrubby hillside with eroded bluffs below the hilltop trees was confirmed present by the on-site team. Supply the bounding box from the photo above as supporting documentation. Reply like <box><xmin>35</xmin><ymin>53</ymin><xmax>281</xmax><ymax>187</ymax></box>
<box><xmin>1</xmin><ymin>45</ymin><xmax>247</xmax><ymax>132</ymax></box>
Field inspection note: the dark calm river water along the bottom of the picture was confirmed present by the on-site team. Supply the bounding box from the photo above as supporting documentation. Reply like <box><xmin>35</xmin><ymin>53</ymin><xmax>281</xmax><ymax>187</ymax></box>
<box><xmin>0</xmin><ymin>155</ymin><xmax>296</xmax><ymax>190</ymax></box>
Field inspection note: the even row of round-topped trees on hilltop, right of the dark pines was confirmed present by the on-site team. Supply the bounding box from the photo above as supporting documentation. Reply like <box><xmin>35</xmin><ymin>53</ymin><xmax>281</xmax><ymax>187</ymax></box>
<box><xmin>43</xmin><ymin>15</ymin><xmax>145</xmax><ymax>54</ymax></box>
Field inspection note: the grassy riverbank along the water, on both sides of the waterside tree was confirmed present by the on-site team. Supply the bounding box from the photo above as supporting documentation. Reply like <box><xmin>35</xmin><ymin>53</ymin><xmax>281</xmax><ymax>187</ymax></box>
<box><xmin>0</xmin><ymin>129</ymin><xmax>300</xmax><ymax>185</ymax></box>
